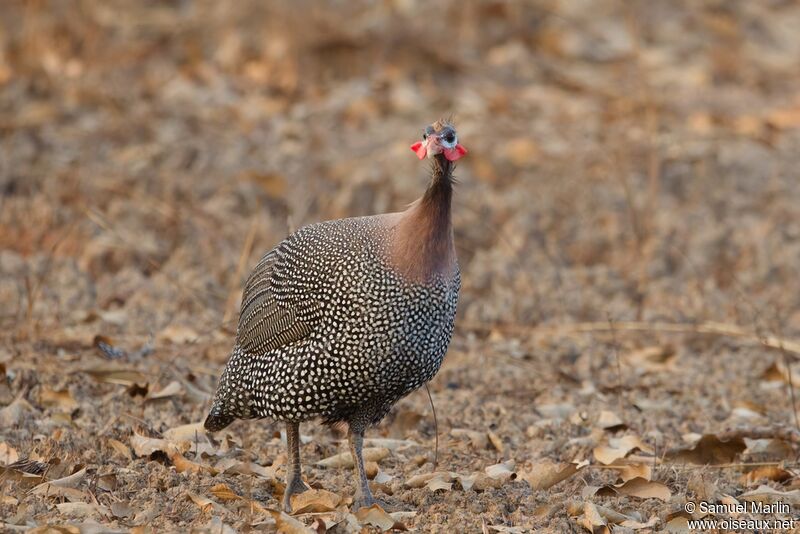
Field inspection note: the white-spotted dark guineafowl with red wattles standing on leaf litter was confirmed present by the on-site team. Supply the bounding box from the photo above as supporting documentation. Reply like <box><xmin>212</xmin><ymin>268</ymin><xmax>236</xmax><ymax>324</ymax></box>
<box><xmin>204</xmin><ymin>119</ymin><xmax>467</xmax><ymax>512</ymax></box>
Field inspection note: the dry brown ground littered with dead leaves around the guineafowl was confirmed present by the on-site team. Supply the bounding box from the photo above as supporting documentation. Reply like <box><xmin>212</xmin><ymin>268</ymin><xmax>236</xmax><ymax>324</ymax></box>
<box><xmin>0</xmin><ymin>0</ymin><xmax>800</xmax><ymax>533</ymax></box>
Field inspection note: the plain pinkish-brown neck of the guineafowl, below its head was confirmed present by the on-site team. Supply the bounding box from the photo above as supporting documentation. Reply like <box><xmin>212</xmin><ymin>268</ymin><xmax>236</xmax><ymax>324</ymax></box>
<box><xmin>392</xmin><ymin>154</ymin><xmax>456</xmax><ymax>283</ymax></box>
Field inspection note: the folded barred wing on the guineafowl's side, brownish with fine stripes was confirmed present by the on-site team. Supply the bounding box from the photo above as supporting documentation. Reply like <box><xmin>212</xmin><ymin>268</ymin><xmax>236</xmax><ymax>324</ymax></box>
<box><xmin>236</xmin><ymin>242</ymin><xmax>321</xmax><ymax>355</ymax></box>
